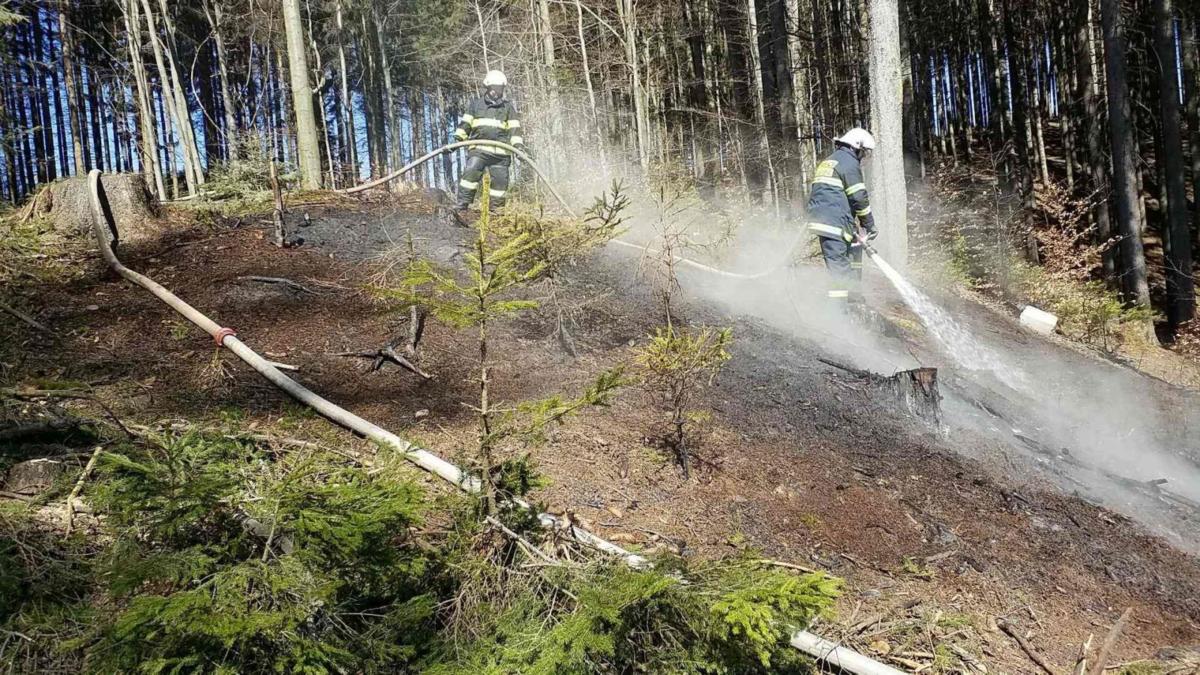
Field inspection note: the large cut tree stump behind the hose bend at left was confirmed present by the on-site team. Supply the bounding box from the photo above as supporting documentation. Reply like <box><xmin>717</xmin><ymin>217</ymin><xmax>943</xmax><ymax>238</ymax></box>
<box><xmin>20</xmin><ymin>173</ymin><xmax>163</xmax><ymax>244</ymax></box>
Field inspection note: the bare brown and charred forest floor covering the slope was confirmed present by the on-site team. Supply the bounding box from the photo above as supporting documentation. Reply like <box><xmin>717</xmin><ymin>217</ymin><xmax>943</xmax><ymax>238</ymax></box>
<box><xmin>0</xmin><ymin>190</ymin><xmax>1200</xmax><ymax>673</ymax></box>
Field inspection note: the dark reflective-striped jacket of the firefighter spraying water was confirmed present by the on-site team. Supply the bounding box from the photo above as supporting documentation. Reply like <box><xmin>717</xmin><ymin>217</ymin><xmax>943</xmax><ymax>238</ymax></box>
<box><xmin>808</xmin><ymin>145</ymin><xmax>875</xmax><ymax>241</ymax></box>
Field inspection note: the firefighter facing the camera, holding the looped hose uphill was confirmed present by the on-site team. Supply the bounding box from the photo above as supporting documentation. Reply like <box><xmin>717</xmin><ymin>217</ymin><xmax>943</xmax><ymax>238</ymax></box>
<box><xmin>454</xmin><ymin>71</ymin><xmax>524</xmax><ymax>211</ymax></box>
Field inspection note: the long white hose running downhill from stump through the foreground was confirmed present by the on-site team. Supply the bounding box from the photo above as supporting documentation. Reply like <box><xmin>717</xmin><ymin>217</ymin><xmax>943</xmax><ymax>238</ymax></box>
<box><xmin>88</xmin><ymin>169</ymin><xmax>904</xmax><ymax>675</ymax></box>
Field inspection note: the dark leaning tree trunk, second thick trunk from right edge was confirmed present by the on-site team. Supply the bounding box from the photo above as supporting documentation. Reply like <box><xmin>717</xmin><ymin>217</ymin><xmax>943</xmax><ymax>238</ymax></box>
<box><xmin>1100</xmin><ymin>0</ymin><xmax>1150</xmax><ymax>307</ymax></box>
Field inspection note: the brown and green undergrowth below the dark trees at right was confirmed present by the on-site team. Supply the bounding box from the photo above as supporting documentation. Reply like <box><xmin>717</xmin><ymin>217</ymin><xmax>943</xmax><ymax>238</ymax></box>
<box><xmin>910</xmin><ymin>156</ymin><xmax>1180</xmax><ymax>352</ymax></box>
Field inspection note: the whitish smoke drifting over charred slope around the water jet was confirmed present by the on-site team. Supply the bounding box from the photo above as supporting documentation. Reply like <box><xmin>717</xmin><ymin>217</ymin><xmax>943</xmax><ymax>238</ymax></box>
<box><xmin>528</xmin><ymin>100</ymin><xmax>1200</xmax><ymax>550</ymax></box>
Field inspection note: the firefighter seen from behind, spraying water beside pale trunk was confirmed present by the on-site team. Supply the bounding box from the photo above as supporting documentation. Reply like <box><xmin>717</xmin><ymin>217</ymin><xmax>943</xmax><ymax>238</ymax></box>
<box><xmin>808</xmin><ymin>129</ymin><xmax>878</xmax><ymax>303</ymax></box>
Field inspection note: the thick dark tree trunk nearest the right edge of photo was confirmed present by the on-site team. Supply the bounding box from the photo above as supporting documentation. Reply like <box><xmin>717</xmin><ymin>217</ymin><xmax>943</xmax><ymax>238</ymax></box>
<box><xmin>1154</xmin><ymin>0</ymin><xmax>1196</xmax><ymax>328</ymax></box>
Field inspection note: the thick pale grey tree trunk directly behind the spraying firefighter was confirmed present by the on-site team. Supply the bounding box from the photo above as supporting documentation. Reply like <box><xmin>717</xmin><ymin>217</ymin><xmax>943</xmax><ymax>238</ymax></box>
<box><xmin>869</xmin><ymin>0</ymin><xmax>908</xmax><ymax>267</ymax></box>
